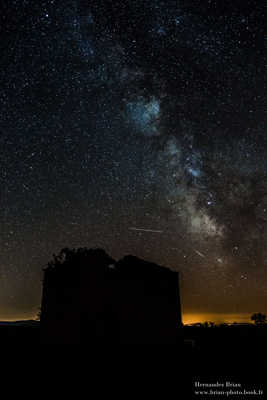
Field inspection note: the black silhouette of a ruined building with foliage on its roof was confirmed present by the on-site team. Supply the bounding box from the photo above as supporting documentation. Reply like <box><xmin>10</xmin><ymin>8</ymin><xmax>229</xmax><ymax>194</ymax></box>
<box><xmin>41</xmin><ymin>248</ymin><xmax>182</xmax><ymax>345</ymax></box>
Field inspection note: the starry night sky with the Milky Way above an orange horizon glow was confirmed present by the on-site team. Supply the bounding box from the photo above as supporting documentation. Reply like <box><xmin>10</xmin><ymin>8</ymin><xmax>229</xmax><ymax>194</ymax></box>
<box><xmin>0</xmin><ymin>0</ymin><xmax>267</xmax><ymax>320</ymax></box>
